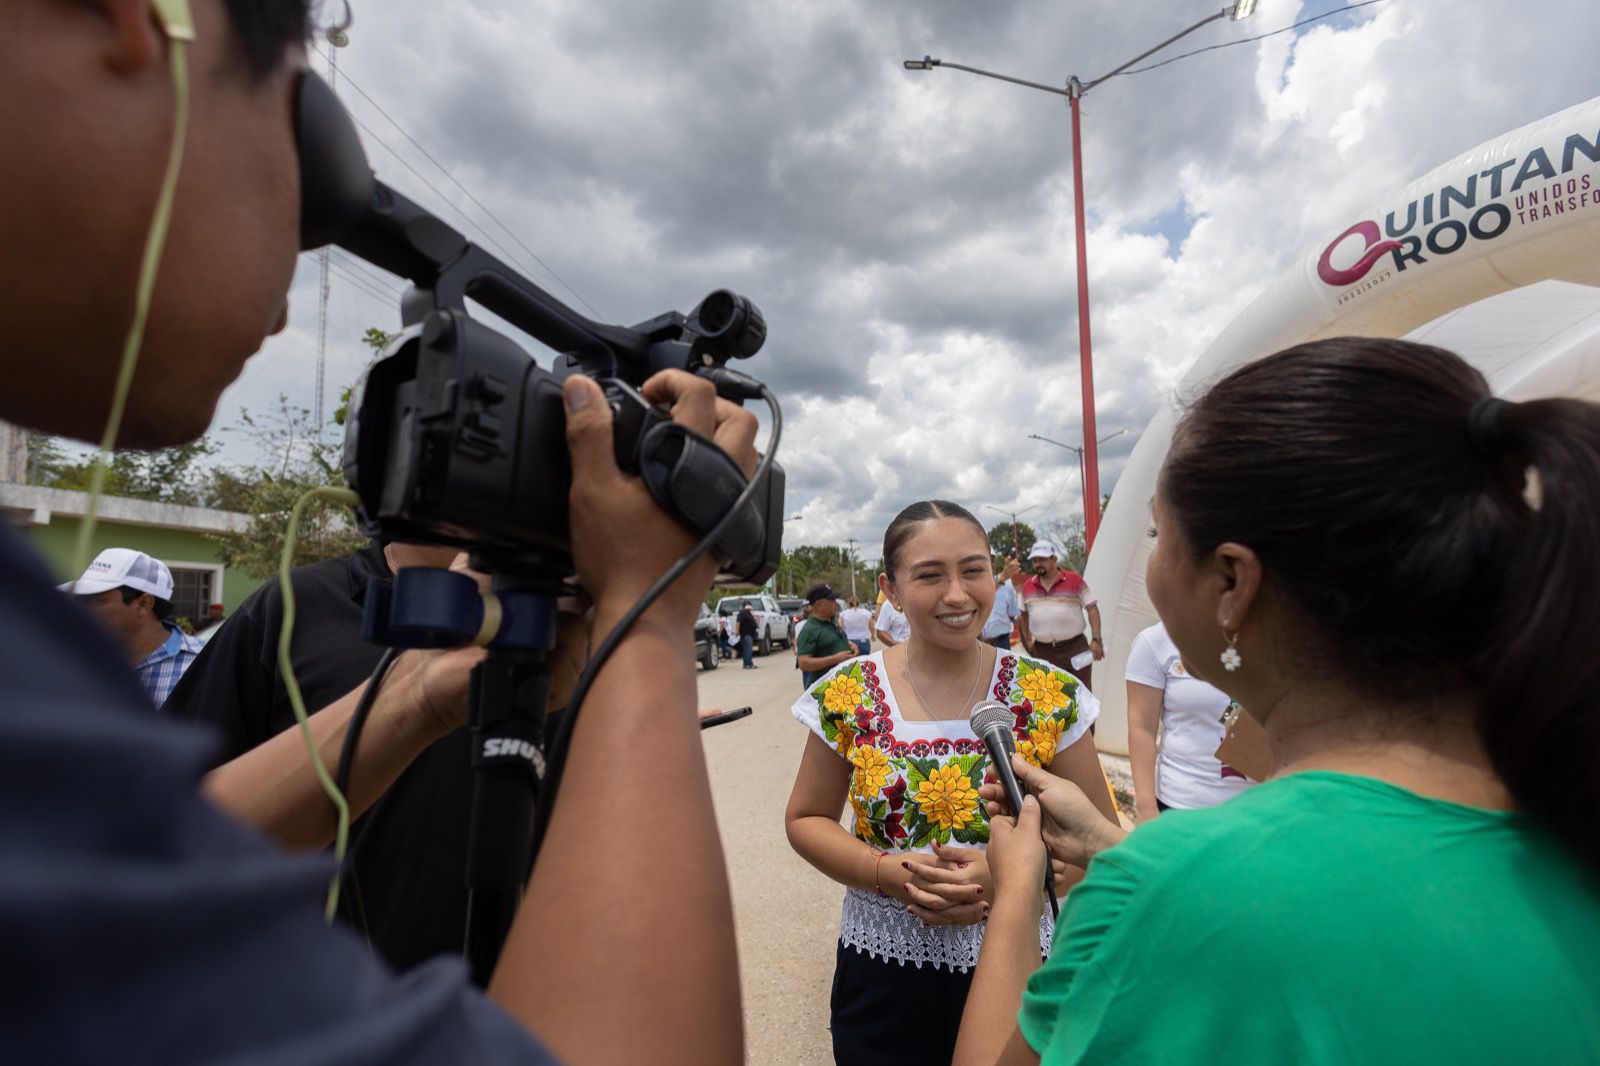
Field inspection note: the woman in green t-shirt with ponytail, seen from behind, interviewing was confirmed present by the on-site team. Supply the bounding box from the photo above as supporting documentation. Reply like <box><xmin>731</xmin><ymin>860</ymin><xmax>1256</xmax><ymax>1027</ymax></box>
<box><xmin>957</xmin><ymin>338</ymin><xmax>1600</xmax><ymax>1063</ymax></box>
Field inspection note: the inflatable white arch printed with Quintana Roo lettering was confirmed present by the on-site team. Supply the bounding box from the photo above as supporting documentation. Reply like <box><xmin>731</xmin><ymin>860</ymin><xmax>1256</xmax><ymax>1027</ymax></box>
<box><xmin>1085</xmin><ymin>98</ymin><xmax>1600</xmax><ymax>754</ymax></box>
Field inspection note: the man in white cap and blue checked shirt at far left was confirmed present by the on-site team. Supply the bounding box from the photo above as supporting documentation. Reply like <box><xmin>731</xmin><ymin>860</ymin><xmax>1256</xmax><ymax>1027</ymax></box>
<box><xmin>61</xmin><ymin>547</ymin><xmax>203</xmax><ymax>707</ymax></box>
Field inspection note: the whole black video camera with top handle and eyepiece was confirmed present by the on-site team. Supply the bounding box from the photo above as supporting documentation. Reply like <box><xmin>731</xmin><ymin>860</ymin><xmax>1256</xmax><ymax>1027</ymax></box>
<box><xmin>296</xmin><ymin>72</ymin><xmax>784</xmax><ymax>584</ymax></box>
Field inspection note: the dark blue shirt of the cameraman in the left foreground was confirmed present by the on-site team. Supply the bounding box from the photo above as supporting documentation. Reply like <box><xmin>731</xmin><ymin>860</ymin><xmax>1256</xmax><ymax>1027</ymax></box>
<box><xmin>0</xmin><ymin>530</ymin><xmax>550</xmax><ymax>1066</ymax></box>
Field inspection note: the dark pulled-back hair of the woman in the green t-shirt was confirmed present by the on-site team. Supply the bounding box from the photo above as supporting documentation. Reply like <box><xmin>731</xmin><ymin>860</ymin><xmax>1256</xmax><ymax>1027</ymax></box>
<box><xmin>1158</xmin><ymin>338</ymin><xmax>1600</xmax><ymax>871</ymax></box>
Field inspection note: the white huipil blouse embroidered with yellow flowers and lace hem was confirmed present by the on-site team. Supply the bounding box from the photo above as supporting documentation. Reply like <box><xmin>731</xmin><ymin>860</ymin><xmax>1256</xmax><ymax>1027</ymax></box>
<box><xmin>792</xmin><ymin>653</ymin><xmax>1099</xmax><ymax>970</ymax></box>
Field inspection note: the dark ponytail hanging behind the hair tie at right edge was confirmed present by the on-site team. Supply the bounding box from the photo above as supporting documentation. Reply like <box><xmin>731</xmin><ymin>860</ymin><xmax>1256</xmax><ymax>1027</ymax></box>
<box><xmin>1475</xmin><ymin>399</ymin><xmax>1600</xmax><ymax>872</ymax></box>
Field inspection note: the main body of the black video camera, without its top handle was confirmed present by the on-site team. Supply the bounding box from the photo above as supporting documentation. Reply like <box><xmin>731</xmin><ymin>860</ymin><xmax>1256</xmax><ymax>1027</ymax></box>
<box><xmin>344</xmin><ymin>299</ymin><xmax>784</xmax><ymax>584</ymax></box>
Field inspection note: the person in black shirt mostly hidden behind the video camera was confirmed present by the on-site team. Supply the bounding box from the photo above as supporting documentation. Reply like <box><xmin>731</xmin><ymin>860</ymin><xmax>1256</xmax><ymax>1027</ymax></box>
<box><xmin>163</xmin><ymin>541</ymin><xmax>472</xmax><ymax>970</ymax></box>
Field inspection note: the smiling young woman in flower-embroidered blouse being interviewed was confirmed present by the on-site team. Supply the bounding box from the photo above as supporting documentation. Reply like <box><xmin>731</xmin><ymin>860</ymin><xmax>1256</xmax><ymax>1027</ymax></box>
<box><xmin>786</xmin><ymin>499</ymin><xmax>1115</xmax><ymax>1063</ymax></box>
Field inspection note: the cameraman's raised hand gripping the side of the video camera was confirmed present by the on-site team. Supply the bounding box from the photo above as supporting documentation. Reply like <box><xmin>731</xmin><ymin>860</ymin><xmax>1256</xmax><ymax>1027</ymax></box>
<box><xmin>563</xmin><ymin>370</ymin><xmax>755</xmax><ymax>619</ymax></box>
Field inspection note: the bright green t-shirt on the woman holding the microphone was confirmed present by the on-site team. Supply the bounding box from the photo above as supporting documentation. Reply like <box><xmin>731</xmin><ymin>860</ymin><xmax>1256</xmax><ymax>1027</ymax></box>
<box><xmin>1019</xmin><ymin>771</ymin><xmax>1600</xmax><ymax>1066</ymax></box>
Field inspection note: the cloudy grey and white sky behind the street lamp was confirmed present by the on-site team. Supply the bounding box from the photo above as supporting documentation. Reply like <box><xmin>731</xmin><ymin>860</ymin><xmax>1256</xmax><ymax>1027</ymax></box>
<box><xmin>218</xmin><ymin>0</ymin><xmax>1600</xmax><ymax>557</ymax></box>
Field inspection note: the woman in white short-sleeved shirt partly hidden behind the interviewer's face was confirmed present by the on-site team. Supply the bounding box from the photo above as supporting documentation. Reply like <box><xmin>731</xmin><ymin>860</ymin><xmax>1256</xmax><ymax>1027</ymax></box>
<box><xmin>1125</xmin><ymin>623</ymin><xmax>1254</xmax><ymax>821</ymax></box>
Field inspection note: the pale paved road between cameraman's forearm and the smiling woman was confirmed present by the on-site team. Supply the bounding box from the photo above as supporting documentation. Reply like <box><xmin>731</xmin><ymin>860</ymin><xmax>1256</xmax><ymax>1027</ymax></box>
<box><xmin>699</xmin><ymin>648</ymin><xmax>845</xmax><ymax>1066</ymax></box>
